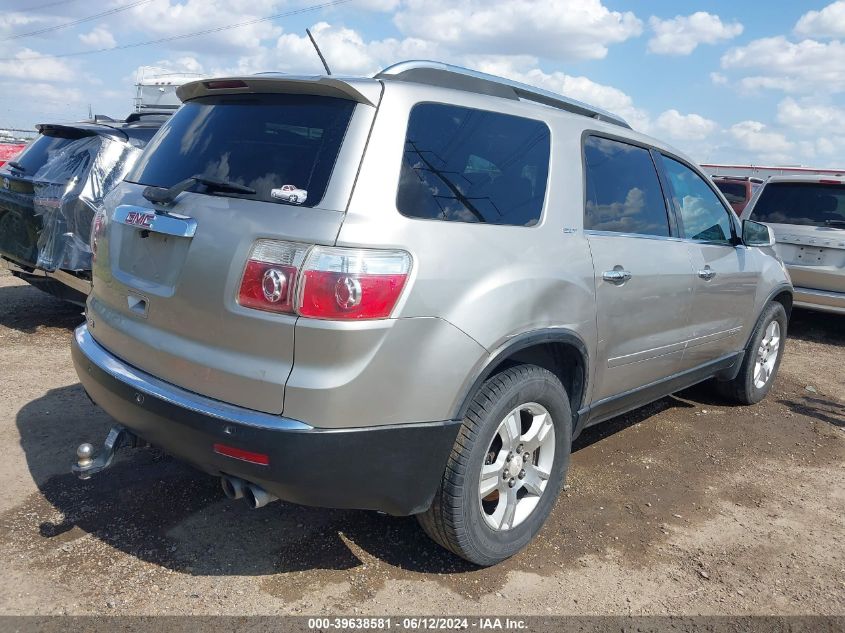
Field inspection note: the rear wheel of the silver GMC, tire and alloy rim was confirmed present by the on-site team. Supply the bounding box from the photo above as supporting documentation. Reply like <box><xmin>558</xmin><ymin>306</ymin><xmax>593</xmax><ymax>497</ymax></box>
<box><xmin>417</xmin><ymin>365</ymin><xmax>572</xmax><ymax>566</ymax></box>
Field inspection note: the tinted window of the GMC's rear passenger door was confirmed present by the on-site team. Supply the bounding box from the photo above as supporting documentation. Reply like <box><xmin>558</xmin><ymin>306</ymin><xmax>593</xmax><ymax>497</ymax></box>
<box><xmin>584</xmin><ymin>136</ymin><xmax>669</xmax><ymax>236</ymax></box>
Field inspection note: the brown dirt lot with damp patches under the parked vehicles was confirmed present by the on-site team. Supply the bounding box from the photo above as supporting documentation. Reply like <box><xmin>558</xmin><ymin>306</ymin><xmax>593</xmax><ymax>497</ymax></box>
<box><xmin>0</xmin><ymin>273</ymin><xmax>845</xmax><ymax>615</ymax></box>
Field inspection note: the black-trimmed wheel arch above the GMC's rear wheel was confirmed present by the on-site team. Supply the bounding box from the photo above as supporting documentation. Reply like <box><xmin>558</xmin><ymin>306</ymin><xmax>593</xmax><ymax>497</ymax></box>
<box><xmin>452</xmin><ymin>329</ymin><xmax>589</xmax><ymax>425</ymax></box>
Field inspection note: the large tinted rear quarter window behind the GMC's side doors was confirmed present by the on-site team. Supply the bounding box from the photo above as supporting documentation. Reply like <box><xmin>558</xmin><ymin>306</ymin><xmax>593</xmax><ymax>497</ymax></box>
<box><xmin>396</xmin><ymin>103</ymin><xmax>549</xmax><ymax>226</ymax></box>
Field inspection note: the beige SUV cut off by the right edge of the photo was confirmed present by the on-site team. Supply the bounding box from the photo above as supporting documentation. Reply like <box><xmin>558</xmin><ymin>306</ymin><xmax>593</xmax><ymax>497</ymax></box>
<box><xmin>742</xmin><ymin>175</ymin><xmax>845</xmax><ymax>314</ymax></box>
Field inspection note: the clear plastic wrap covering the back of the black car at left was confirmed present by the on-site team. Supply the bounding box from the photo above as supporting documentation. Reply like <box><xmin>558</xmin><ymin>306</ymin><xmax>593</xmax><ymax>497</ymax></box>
<box><xmin>33</xmin><ymin>136</ymin><xmax>141</xmax><ymax>271</ymax></box>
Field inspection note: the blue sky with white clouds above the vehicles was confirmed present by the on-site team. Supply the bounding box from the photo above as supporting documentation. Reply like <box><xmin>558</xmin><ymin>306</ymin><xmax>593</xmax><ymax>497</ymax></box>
<box><xmin>0</xmin><ymin>0</ymin><xmax>845</xmax><ymax>167</ymax></box>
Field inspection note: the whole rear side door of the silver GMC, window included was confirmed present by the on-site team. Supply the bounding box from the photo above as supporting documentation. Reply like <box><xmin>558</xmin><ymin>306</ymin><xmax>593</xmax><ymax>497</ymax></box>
<box><xmin>584</xmin><ymin>136</ymin><xmax>693</xmax><ymax>402</ymax></box>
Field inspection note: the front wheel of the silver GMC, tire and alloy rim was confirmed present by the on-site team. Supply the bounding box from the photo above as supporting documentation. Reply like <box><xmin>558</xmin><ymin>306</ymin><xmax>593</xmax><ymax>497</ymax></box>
<box><xmin>716</xmin><ymin>302</ymin><xmax>787</xmax><ymax>404</ymax></box>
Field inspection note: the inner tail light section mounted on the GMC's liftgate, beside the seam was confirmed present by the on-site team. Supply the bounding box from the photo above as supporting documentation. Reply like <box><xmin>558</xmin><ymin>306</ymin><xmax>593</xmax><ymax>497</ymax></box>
<box><xmin>238</xmin><ymin>240</ymin><xmax>308</xmax><ymax>314</ymax></box>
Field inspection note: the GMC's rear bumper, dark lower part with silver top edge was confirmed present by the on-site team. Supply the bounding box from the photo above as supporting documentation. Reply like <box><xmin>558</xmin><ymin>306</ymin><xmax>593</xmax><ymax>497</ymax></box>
<box><xmin>72</xmin><ymin>325</ymin><xmax>460</xmax><ymax>515</ymax></box>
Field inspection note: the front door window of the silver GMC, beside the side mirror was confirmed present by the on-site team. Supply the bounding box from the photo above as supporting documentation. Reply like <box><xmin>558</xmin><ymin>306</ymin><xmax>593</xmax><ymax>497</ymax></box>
<box><xmin>663</xmin><ymin>156</ymin><xmax>733</xmax><ymax>243</ymax></box>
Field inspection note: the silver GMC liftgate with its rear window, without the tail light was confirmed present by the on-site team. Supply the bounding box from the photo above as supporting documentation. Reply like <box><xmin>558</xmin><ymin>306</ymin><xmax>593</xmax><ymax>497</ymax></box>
<box><xmin>89</xmin><ymin>93</ymin><xmax>375</xmax><ymax>413</ymax></box>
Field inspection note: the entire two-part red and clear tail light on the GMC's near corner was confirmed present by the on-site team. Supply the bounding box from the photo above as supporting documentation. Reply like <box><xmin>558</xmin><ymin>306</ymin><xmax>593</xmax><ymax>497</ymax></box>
<box><xmin>238</xmin><ymin>240</ymin><xmax>411</xmax><ymax>320</ymax></box>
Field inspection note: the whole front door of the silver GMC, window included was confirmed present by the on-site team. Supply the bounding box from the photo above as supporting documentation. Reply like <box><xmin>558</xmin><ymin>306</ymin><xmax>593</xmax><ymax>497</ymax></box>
<box><xmin>660</xmin><ymin>155</ymin><xmax>759</xmax><ymax>369</ymax></box>
